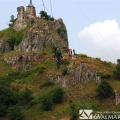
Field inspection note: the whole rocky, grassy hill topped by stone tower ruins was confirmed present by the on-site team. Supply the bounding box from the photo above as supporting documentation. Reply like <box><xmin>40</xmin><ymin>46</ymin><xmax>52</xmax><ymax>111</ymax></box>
<box><xmin>0</xmin><ymin>2</ymin><xmax>120</xmax><ymax>120</ymax></box>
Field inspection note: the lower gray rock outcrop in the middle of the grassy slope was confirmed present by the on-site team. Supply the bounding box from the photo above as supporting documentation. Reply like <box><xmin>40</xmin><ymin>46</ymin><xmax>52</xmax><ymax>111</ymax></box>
<box><xmin>48</xmin><ymin>63</ymin><xmax>101</xmax><ymax>87</ymax></box>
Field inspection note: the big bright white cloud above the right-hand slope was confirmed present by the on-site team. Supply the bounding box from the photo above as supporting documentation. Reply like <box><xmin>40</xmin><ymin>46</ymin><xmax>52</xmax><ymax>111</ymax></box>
<box><xmin>79</xmin><ymin>20</ymin><xmax>120</xmax><ymax>62</ymax></box>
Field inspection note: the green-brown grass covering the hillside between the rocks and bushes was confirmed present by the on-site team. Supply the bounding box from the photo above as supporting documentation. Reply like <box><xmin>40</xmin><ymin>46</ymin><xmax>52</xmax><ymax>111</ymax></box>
<box><xmin>0</xmin><ymin>53</ymin><xmax>120</xmax><ymax>120</ymax></box>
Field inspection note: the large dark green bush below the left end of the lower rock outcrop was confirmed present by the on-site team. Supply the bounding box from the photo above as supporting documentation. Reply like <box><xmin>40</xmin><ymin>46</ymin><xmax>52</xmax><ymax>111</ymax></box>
<box><xmin>38</xmin><ymin>86</ymin><xmax>64</xmax><ymax>111</ymax></box>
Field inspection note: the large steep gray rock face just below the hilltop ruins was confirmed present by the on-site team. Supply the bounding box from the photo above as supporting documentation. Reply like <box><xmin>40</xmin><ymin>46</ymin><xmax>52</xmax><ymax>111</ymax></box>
<box><xmin>16</xmin><ymin>18</ymin><xmax>68</xmax><ymax>52</ymax></box>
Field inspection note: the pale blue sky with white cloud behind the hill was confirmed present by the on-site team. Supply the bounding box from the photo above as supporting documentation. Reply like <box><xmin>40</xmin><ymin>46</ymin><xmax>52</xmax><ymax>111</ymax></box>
<box><xmin>0</xmin><ymin>0</ymin><xmax>120</xmax><ymax>62</ymax></box>
